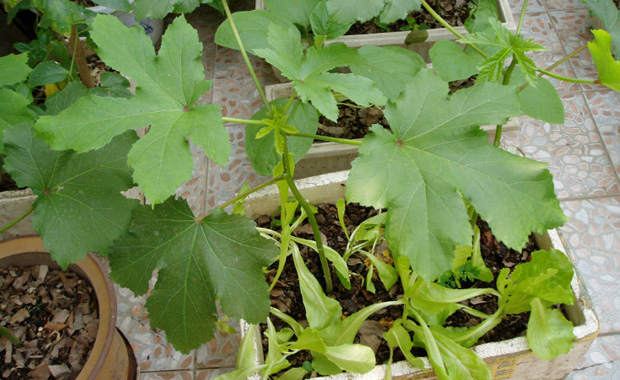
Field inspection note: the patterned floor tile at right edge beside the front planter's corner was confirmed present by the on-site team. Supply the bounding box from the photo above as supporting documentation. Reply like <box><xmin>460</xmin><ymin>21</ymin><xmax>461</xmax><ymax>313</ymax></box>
<box><xmin>562</xmin><ymin>197</ymin><xmax>620</xmax><ymax>334</ymax></box>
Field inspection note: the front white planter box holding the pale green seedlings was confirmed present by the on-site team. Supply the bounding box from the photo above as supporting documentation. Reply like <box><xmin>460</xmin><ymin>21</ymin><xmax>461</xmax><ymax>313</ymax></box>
<box><xmin>241</xmin><ymin>171</ymin><xmax>599</xmax><ymax>380</ymax></box>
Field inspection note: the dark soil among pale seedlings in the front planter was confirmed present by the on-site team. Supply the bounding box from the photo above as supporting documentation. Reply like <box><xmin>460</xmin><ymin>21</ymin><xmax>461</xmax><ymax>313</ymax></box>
<box><xmin>257</xmin><ymin>204</ymin><xmax>538</xmax><ymax>372</ymax></box>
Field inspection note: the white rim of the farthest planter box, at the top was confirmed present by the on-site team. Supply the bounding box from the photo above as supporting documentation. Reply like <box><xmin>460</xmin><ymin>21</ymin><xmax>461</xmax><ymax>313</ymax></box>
<box><xmin>256</xmin><ymin>0</ymin><xmax>517</xmax><ymax>62</ymax></box>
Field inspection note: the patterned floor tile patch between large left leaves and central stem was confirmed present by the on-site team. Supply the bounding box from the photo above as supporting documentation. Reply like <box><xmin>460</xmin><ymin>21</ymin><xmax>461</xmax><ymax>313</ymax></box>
<box><xmin>206</xmin><ymin>124</ymin><xmax>267</xmax><ymax>210</ymax></box>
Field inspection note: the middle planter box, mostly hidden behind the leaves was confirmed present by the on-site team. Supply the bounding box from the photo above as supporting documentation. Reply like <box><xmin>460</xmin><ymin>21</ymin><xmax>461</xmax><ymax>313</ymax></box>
<box><xmin>265</xmin><ymin>82</ymin><xmax>521</xmax><ymax>178</ymax></box>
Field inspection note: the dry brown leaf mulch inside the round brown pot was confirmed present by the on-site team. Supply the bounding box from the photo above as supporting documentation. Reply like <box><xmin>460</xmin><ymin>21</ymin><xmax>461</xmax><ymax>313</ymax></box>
<box><xmin>0</xmin><ymin>265</ymin><xmax>99</xmax><ymax>380</ymax></box>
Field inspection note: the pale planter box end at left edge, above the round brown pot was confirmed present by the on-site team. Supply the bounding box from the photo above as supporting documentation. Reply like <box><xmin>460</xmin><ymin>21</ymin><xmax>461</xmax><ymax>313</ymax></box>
<box><xmin>0</xmin><ymin>189</ymin><xmax>37</xmax><ymax>240</ymax></box>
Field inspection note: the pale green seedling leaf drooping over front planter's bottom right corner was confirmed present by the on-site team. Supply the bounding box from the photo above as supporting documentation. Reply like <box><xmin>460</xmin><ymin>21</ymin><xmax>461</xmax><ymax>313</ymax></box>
<box><xmin>527</xmin><ymin>298</ymin><xmax>576</xmax><ymax>360</ymax></box>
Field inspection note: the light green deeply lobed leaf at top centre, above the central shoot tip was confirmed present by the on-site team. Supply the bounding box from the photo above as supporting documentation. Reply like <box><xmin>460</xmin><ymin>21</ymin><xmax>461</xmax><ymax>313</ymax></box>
<box><xmin>256</xmin><ymin>24</ymin><xmax>385</xmax><ymax>121</ymax></box>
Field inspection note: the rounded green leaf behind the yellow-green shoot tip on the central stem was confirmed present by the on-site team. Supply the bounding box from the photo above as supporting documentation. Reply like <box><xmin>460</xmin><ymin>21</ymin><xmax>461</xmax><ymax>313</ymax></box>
<box><xmin>245</xmin><ymin>99</ymin><xmax>319</xmax><ymax>176</ymax></box>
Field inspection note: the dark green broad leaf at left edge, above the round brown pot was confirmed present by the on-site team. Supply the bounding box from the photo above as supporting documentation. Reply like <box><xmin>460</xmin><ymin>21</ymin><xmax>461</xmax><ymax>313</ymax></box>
<box><xmin>4</xmin><ymin>125</ymin><xmax>138</xmax><ymax>268</ymax></box>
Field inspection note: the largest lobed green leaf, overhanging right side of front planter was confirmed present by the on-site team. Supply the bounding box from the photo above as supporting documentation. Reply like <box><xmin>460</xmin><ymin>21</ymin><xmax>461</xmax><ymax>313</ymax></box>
<box><xmin>347</xmin><ymin>69</ymin><xmax>566</xmax><ymax>281</ymax></box>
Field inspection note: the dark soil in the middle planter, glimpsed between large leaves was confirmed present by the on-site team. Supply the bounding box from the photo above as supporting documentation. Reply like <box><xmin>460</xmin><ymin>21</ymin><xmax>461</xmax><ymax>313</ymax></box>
<box><xmin>314</xmin><ymin>77</ymin><xmax>476</xmax><ymax>142</ymax></box>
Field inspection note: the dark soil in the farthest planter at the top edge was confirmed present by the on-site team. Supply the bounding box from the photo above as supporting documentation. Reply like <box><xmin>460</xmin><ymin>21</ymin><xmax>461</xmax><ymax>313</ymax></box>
<box><xmin>347</xmin><ymin>0</ymin><xmax>469</xmax><ymax>34</ymax></box>
